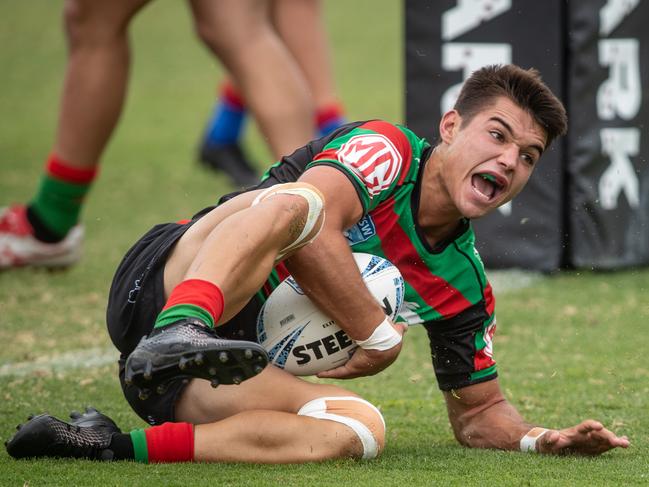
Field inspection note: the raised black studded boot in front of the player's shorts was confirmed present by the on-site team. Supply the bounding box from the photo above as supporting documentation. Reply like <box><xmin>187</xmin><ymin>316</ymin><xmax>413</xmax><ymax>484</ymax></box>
<box><xmin>124</xmin><ymin>318</ymin><xmax>268</xmax><ymax>400</ymax></box>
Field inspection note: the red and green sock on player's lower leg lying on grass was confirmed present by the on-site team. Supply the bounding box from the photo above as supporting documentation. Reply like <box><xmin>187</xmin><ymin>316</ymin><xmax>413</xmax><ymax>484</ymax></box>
<box><xmin>128</xmin><ymin>423</ymin><xmax>194</xmax><ymax>463</ymax></box>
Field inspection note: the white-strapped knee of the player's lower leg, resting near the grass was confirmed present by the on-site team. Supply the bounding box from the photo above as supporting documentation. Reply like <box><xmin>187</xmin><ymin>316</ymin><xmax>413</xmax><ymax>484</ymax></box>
<box><xmin>298</xmin><ymin>396</ymin><xmax>385</xmax><ymax>460</ymax></box>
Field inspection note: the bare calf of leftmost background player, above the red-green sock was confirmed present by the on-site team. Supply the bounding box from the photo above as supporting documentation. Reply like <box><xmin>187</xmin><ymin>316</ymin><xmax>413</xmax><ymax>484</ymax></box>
<box><xmin>54</xmin><ymin>0</ymin><xmax>149</xmax><ymax>168</ymax></box>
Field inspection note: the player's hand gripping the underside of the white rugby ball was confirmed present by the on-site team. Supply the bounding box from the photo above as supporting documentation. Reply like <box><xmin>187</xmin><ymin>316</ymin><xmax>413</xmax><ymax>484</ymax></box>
<box><xmin>318</xmin><ymin>323</ymin><xmax>408</xmax><ymax>379</ymax></box>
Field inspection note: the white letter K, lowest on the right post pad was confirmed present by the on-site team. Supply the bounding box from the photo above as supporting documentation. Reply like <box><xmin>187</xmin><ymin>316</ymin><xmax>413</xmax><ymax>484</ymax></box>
<box><xmin>599</xmin><ymin>128</ymin><xmax>640</xmax><ymax>210</ymax></box>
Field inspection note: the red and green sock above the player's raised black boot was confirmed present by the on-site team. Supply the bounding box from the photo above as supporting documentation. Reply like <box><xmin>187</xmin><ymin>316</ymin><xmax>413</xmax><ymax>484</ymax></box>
<box><xmin>153</xmin><ymin>279</ymin><xmax>223</xmax><ymax>328</ymax></box>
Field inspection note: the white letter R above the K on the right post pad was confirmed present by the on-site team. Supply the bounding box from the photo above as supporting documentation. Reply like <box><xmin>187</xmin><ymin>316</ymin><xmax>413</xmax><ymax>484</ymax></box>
<box><xmin>597</xmin><ymin>39</ymin><xmax>642</xmax><ymax>120</ymax></box>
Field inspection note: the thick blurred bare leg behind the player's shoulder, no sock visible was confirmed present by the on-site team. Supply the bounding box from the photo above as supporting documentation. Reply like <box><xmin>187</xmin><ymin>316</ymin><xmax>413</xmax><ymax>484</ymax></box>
<box><xmin>191</xmin><ymin>0</ymin><xmax>313</xmax><ymax>159</ymax></box>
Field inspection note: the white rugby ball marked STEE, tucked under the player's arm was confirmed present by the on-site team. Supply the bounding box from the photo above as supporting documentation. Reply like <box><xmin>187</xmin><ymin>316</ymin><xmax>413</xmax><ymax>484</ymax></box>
<box><xmin>257</xmin><ymin>253</ymin><xmax>404</xmax><ymax>375</ymax></box>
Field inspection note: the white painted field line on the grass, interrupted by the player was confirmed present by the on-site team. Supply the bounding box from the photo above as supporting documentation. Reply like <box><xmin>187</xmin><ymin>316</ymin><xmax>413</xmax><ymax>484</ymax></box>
<box><xmin>0</xmin><ymin>270</ymin><xmax>545</xmax><ymax>377</ymax></box>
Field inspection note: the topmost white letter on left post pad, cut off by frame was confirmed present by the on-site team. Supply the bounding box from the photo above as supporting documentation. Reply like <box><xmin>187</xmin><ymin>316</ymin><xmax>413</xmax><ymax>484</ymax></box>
<box><xmin>442</xmin><ymin>0</ymin><xmax>512</xmax><ymax>41</ymax></box>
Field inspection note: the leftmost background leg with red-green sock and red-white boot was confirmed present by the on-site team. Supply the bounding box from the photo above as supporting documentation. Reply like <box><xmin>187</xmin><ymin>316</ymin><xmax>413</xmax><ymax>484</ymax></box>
<box><xmin>0</xmin><ymin>0</ymin><xmax>148</xmax><ymax>268</ymax></box>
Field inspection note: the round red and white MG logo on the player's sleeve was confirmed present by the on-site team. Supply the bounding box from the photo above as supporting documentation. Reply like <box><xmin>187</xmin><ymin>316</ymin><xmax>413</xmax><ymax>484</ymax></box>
<box><xmin>336</xmin><ymin>134</ymin><xmax>403</xmax><ymax>197</ymax></box>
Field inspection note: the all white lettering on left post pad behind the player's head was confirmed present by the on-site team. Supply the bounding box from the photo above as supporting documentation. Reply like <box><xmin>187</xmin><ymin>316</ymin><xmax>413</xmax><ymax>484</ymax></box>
<box><xmin>440</xmin><ymin>0</ymin><xmax>512</xmax><ymax>216</ymax></box>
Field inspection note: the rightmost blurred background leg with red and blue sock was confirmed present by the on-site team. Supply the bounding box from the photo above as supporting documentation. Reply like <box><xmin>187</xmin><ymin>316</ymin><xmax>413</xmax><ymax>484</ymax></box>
<box><xmin>272</xmin><ymin>0</ymin><xmax>345</xmax><ymax>135</ymax></box>
